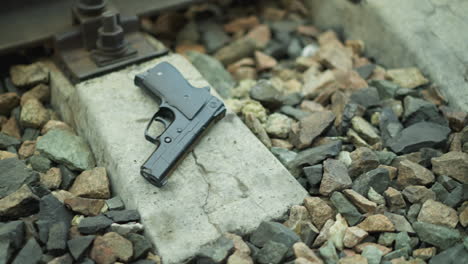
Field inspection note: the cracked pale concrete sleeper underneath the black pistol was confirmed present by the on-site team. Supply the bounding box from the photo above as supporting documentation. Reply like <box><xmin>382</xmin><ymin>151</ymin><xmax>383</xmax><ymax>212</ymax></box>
<box><xmin>44</xmin><ymin>55</ymin><xmax>307</xmax><ymax>264</ymax></box>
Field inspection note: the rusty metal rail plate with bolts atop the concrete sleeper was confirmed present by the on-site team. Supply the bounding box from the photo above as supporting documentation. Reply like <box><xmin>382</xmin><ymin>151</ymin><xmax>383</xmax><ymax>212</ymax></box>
<box><xmin>54</xmin><ymin>0</ymin><xmax>168</xmax><ymax>83</ymax></box>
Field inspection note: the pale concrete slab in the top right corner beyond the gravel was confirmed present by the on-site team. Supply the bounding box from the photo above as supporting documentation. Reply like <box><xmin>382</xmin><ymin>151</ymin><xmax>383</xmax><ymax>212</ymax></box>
<box><xmin>306</xmin><ymin>0</ymin><xmax>468</xmax><ymax>111</ymax></box>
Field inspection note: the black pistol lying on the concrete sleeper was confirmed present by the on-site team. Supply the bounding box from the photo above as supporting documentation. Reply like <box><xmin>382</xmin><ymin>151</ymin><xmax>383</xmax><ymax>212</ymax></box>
<box><xmin>135</xmin><ymin>62</ymin><xmax>226</xmax><ymax>187</ymax></box>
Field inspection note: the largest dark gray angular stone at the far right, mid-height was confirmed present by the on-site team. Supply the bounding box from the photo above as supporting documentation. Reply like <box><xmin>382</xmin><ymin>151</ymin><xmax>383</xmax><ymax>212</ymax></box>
<box><xmin>388</xmin><ymin>122</ymin><xmax>450</xmax><ymax>154</ymax></box>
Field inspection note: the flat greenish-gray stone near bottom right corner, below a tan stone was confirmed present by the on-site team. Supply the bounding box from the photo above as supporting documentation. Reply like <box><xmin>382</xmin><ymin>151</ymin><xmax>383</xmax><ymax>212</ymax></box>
<box><xmin>413</xmin><ymin>222</ymin><xmax>461</xmax><ymax>249</ymax></box>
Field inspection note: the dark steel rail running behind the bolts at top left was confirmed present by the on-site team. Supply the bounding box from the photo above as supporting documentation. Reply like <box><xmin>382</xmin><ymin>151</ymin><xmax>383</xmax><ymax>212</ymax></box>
<box><xmin>0</xmin><ymin>0</ymin><xmax>202</xmax><ymax>55</ymax></box>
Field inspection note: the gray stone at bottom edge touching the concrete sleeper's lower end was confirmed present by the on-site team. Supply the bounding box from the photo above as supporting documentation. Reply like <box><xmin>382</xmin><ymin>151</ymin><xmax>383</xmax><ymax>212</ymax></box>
<box><xmin>197</xmin><ymin>237</ymin><xmax>234</xmax><ymax>264</ymax></box>
